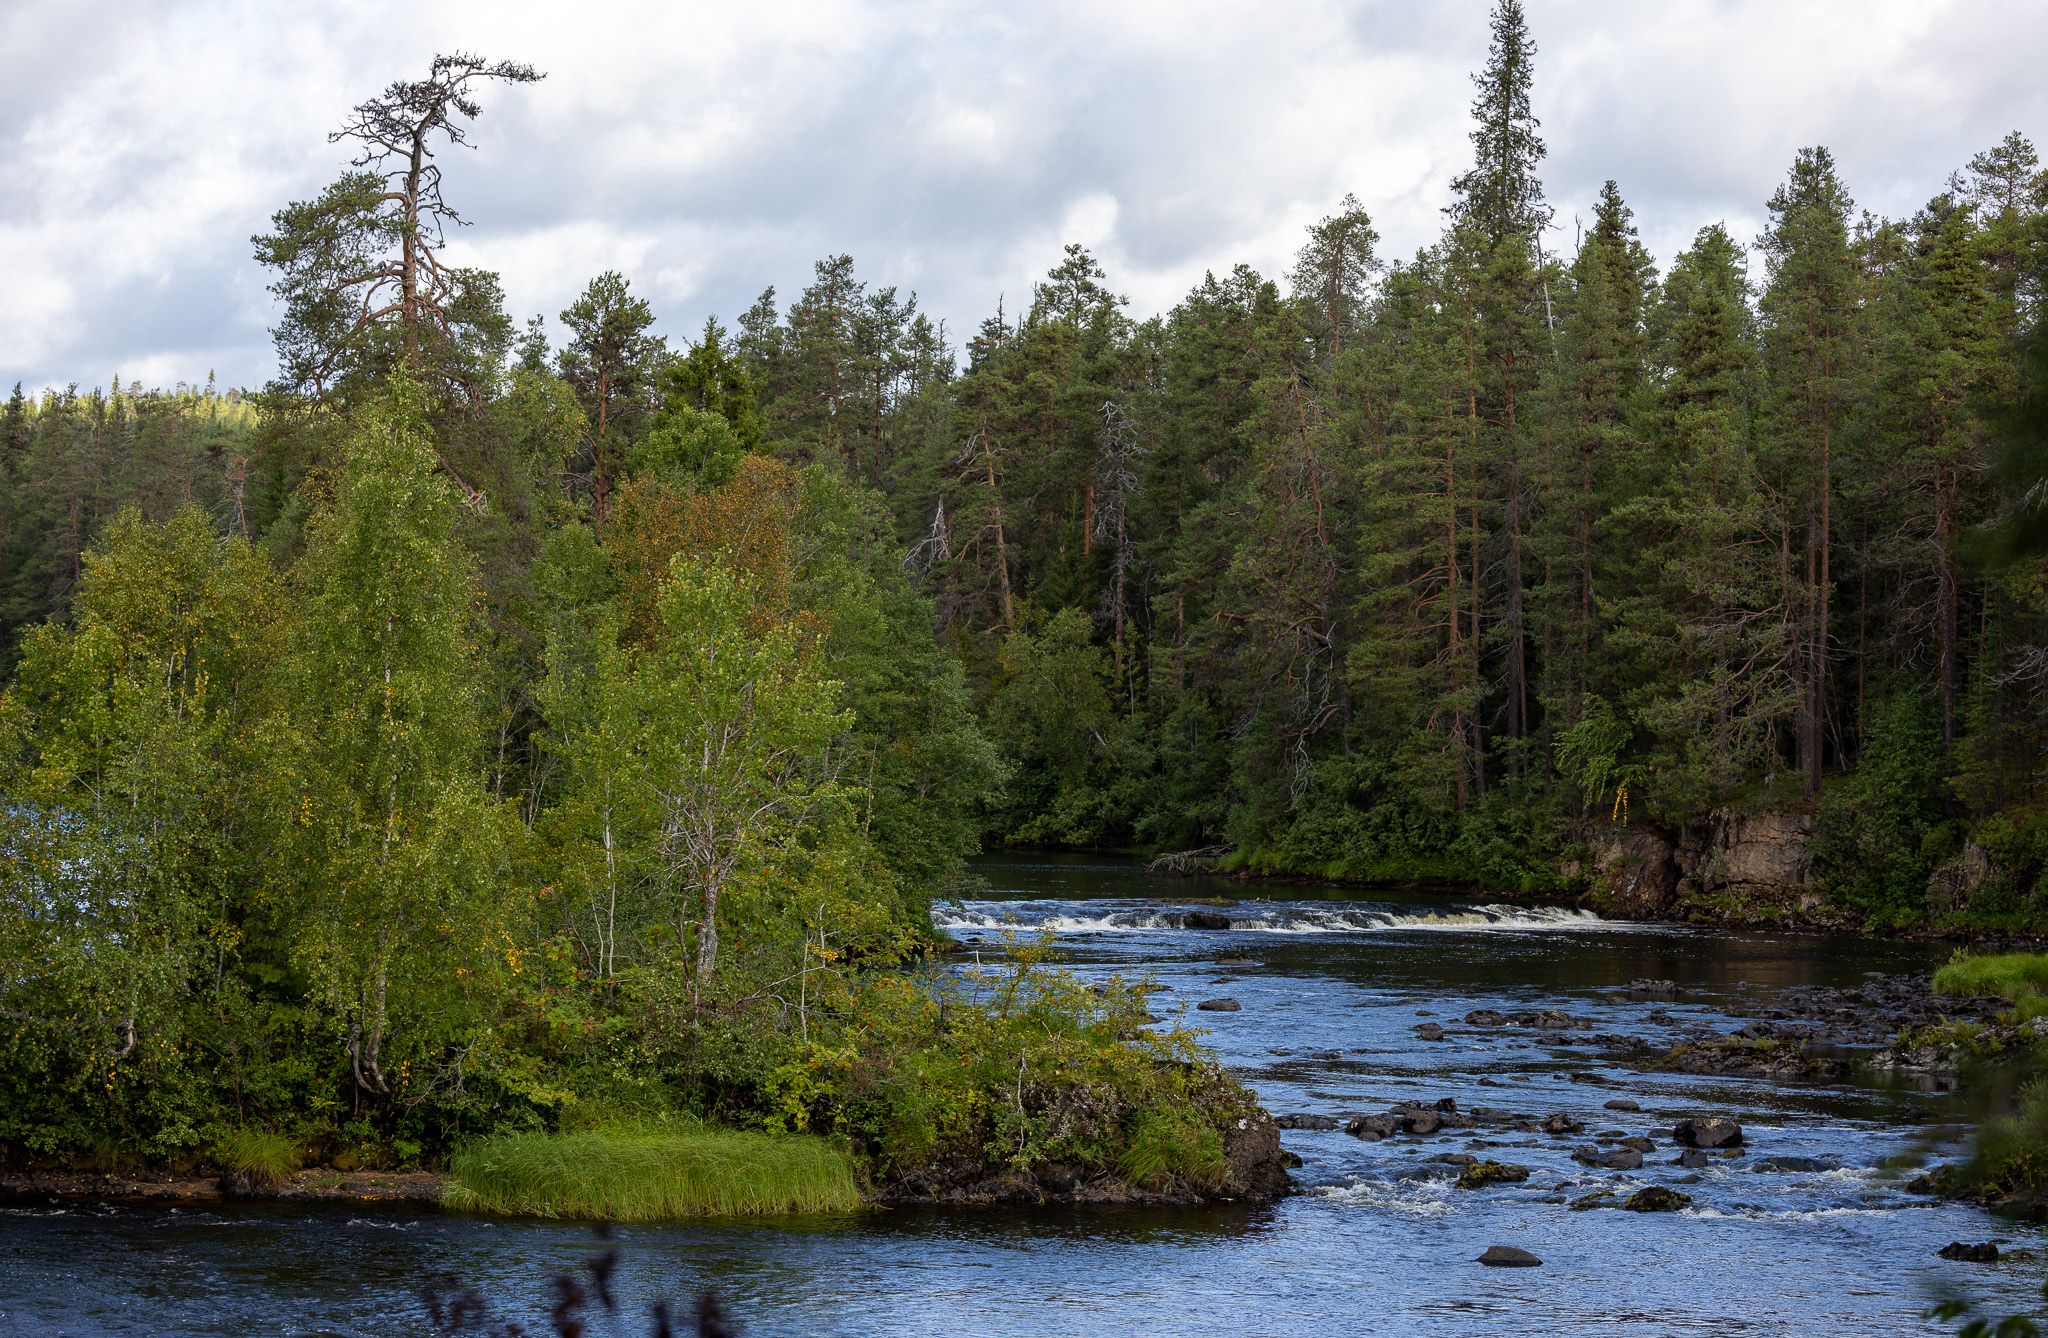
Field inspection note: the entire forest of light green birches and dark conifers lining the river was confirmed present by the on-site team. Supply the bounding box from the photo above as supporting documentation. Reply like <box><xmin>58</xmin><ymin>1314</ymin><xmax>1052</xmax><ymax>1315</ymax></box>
<box><xmin>0</xmin><ymin>0</ymin><xmax>2048</xmax><ymax>1160</ymax></box>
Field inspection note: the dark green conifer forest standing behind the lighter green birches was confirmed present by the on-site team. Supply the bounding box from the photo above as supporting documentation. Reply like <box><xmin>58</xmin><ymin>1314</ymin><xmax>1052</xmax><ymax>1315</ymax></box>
<box><xmin>0</xmin><ymin>2</ymin><xmax>2048</xmax><ymax>922</ymax></box>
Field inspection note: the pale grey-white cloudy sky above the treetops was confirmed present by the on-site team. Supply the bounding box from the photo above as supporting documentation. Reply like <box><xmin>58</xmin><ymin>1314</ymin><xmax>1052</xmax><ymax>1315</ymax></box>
<box><xmin>0</xmin><ymin>0</ymin><xmax>2048</xmax><ymax>389</ymax></box>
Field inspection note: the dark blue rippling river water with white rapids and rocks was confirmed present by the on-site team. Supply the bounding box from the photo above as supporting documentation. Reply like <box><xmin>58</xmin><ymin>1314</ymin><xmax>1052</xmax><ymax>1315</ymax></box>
<box><xmin>0</xmin><ymin>856</ymin><xmax>2048</xmax><ymax>1338</ymax></box>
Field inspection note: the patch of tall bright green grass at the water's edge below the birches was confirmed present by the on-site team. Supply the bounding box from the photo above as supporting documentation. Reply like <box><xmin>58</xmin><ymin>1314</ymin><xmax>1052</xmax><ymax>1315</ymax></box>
<box><xmin>444</xmin><ymin>1127</ymin><xmax>860</xmax><ymax>1221</ymax></box>
